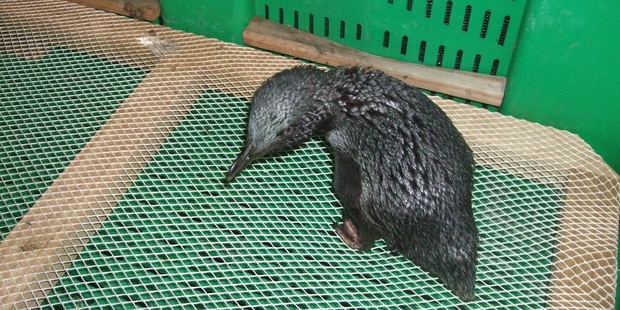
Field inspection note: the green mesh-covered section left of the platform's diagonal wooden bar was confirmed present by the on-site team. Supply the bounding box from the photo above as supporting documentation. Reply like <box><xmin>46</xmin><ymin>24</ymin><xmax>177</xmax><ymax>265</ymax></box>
<box><xmin>0</xmin><ymin>48</ymin><xmax>146</xmax><ymax>240</ymax></box>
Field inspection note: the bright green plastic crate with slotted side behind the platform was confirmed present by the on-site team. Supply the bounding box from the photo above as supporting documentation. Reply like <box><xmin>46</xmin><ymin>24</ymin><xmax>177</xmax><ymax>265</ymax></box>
<box><xmin>161</xmin><ymin>0</ymin><xmax>620</xmax><ymax>171</ymax></box>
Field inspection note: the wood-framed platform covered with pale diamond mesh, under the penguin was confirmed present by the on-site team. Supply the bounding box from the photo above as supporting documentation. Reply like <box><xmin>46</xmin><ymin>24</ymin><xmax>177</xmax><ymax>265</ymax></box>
<box><xmin>0</xmin><ymin>0</ymin><xmax>620</xmax><ymax>309</ymax></box>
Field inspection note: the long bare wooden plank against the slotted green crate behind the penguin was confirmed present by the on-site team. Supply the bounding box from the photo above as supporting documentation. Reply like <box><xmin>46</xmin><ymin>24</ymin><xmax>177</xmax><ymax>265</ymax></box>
<box><xmin>243</xmin><ymin>17</ymin><xmax>506</xmax><ymax>106</ymax></box>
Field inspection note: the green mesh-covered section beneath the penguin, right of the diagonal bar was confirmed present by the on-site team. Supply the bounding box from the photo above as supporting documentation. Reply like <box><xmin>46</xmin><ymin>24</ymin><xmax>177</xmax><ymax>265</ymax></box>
<box><xmin>38</xmin><ymin>91</ymin><xmax>559</xmax><ymax>309</ymax></box>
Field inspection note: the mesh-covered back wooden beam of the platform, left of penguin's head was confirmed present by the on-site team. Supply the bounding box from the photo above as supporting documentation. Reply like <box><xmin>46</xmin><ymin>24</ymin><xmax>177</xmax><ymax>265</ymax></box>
<box><xmin>0</xmin><ymin>0</ymin><xmax>302</xmax><ymax>91</ymax></box>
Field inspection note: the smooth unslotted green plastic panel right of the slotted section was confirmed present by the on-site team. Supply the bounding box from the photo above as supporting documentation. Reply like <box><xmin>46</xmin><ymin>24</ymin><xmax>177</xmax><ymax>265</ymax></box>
<box><xmin>502</xmin><ymin>0</ymin><xmax>620</xmax><ymax>172</ymax></box>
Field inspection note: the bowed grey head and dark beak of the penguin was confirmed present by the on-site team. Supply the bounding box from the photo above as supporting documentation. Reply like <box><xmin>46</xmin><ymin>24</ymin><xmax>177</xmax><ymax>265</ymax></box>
<box><xmin>226</xmin><ymin>66</ymin><xmax>327</xmax><ymax>181</ymax></box>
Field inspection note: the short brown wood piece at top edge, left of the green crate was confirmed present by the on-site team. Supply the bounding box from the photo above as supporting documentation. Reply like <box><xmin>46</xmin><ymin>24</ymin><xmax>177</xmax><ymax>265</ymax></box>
<box><xmin>66</xmin><ymin>0</ymin><xmax>161</xmax><ymax>22</ymax></box>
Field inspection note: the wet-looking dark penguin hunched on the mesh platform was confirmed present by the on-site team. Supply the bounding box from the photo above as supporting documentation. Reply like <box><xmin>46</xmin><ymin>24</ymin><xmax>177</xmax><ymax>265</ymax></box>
<box><xmin>226</xmin><ymin>66</ymin><xmax>478</xmax><ymax>301</ymax></box>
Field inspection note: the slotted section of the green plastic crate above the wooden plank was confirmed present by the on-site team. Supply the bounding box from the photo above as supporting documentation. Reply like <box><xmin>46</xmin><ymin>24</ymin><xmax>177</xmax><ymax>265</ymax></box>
<box><xmin>255</xmin><ymin>0</ymin><xmax>527</xmax><ymax>111</ymax></box>
